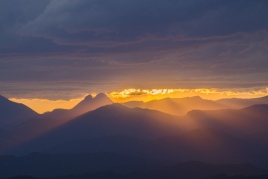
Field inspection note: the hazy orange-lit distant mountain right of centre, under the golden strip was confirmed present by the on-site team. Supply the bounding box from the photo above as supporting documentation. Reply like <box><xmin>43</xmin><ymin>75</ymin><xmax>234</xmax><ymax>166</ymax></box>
<box><xmin>123</xmin><ymin>96</ymin><xmax>226</xmax><ymax>116</ymax></box>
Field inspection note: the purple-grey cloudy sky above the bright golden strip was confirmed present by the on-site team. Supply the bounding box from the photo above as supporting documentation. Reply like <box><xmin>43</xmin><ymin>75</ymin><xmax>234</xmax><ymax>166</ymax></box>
<box><xmin>0</xmin><ymin>0</ymin><xmax>268</xmax><ymax>112</ymax></box>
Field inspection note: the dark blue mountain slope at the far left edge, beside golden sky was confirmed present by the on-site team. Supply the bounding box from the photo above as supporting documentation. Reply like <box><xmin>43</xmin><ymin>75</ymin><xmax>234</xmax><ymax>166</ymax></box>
<box><xmin>0</xmin><ymin>95</ymin><xmax>38</xmax><ymax>129</ymax></box>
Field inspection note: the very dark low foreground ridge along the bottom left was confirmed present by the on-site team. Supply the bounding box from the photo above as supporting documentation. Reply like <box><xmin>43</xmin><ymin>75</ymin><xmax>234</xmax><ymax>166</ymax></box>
<box><xmin>0</xmin><ymin>153</ymin><xmax>175</xmax><ymax>178</ymax></box>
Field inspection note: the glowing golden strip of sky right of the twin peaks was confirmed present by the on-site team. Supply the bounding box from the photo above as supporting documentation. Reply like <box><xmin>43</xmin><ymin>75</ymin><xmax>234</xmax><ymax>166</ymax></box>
<box><xmin>109</xmin><ymin>88</ymin><xmax>268</xmax><ymax>102</ymax></box>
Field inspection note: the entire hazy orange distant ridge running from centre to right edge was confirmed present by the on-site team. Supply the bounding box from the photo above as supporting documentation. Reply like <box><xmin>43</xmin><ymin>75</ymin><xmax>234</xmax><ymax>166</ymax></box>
<box><xmin>123</xmin><ymin>96</ymin><xmax>268</xmax><ymax>116</ymax></box>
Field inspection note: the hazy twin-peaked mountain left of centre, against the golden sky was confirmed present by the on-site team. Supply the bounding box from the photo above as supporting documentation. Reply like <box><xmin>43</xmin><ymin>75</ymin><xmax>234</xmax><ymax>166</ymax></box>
<box><xmin>42</xmin><ymin>93</ymin><xmax>113</xmax><ymax>119</ymax></box>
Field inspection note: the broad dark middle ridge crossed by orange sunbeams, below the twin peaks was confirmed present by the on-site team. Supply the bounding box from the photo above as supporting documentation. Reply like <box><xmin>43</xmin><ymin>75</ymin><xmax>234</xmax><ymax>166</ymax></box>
<box><xmin>1</xmin><ymin>104</ymin><xmax>268</xmax><ymax>166</ymax></box>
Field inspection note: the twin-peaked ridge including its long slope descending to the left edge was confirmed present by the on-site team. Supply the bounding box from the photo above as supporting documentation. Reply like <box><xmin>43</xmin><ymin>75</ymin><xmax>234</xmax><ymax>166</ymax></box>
<box><xmin>0</xmin><ymin>94</ymin><xmax>112</xmax><ymax>151</ymax></box>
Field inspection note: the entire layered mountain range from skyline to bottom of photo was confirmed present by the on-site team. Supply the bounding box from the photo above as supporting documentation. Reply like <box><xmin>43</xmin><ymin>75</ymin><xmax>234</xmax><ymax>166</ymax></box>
<box><xmin>0</xmin><ymin>94</ymin><xmax>268</xmax><ymax>178</ymax></box>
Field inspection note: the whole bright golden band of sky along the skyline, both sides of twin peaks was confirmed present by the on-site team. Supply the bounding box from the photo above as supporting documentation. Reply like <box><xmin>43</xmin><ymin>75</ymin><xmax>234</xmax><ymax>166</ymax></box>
<box><xmin>10</xmin><ymin>88</ymin><xmax>268</xmax><ymax>113</ymax></box>
